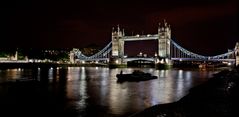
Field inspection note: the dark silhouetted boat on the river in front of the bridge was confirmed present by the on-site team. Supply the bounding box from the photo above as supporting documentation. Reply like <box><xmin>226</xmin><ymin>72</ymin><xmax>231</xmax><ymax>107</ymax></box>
<box><xmin>116</xmin><ymin>70</ymin><xmax>158</xmax><ymax>82</ymax></box>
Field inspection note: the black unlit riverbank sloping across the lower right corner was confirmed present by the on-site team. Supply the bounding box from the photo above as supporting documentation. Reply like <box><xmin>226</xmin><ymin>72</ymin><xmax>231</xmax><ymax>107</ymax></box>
<box><xmin>131</xmin><ymin>67</ymin><xmax>239</xmax><ymax>117</ymax></box>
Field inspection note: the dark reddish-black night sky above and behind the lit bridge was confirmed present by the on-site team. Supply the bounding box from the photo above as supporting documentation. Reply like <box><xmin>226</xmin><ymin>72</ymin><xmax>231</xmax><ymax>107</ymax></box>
<box><xmin>0</xmin><ymin>0</ymin><xmax>239</xmax><ymax>55</ymax></box>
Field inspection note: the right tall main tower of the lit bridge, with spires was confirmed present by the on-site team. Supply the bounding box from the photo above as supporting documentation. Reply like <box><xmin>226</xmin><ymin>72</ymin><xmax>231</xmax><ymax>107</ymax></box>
<box><xmin>158</xmin><ymin>20</ymin><xmax>171</xmax><ymax>59</ymax></box>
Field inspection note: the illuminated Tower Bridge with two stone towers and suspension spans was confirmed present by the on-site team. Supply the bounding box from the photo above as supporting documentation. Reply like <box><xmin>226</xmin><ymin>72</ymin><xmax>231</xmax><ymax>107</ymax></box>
<box><xmin>70</xmin><ymin>21</ymin><xmax>239</xmax><ymax>65</ymax></box>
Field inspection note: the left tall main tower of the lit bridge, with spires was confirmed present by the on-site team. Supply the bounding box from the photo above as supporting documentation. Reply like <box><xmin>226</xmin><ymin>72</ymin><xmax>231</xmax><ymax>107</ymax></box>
<box><xmin>110</xmin><ymin>25</ymin><xmax>124</xmax><ymax>64</ymax></box>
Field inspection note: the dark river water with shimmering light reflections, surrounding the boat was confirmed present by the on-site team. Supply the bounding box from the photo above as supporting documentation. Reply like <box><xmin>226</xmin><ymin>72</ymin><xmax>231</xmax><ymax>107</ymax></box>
<box><xmin>0</xmin><ymin>67</ymin><xmax>218</xmax><ymax>117</ymax></box>
